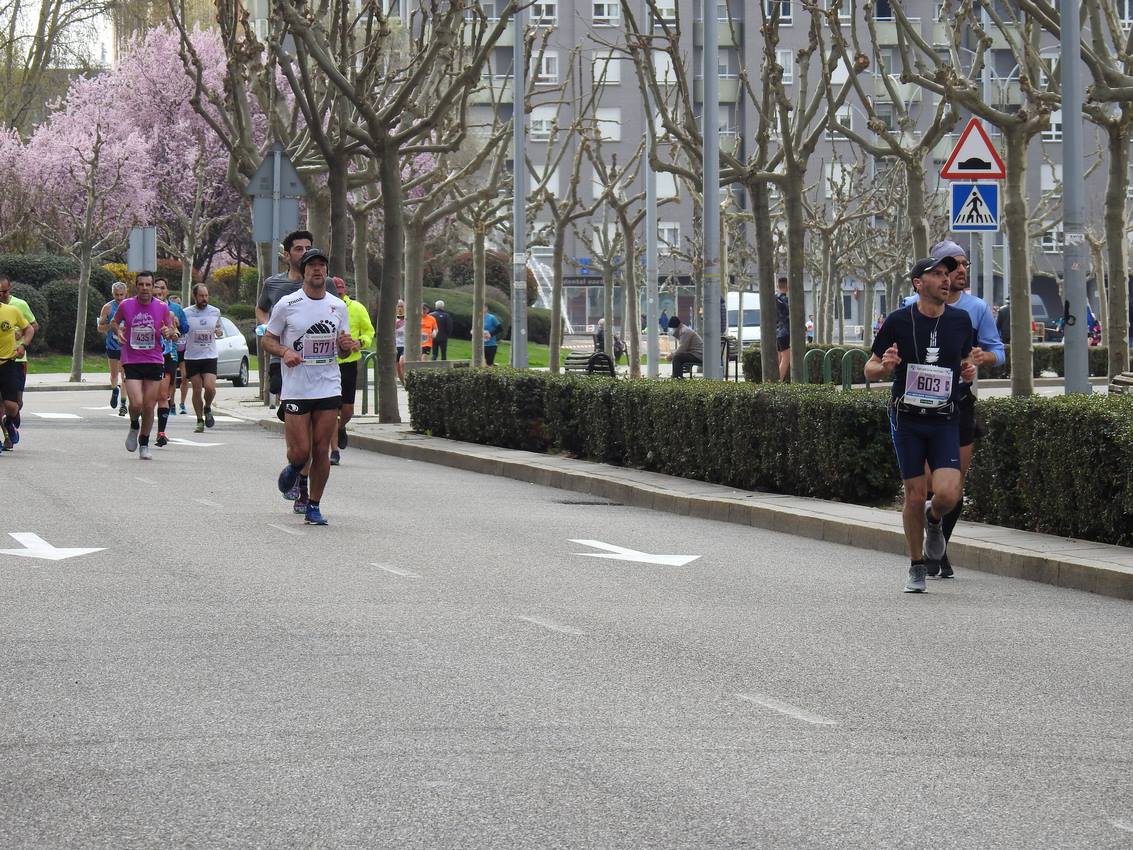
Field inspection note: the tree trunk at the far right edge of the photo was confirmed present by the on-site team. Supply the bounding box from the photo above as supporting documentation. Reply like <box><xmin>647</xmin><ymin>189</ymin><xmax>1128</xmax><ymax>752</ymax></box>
<box><xmin>1098</xmin><ymin>125</ymin><xmax>1130</xmax><ymax>377</ymax></box>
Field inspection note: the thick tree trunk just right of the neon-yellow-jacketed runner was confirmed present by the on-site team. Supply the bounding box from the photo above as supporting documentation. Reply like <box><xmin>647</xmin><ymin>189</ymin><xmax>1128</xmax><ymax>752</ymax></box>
<box><xmin>376</xmin><ymin>144</ymin><xmax>411</xmax><ymax>423</ymax></box>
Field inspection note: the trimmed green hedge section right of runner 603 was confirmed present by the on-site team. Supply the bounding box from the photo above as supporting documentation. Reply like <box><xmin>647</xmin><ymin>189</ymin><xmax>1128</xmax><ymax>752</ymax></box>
<box><xmin>965</xmin><ymin>396</ymin><xmax>1133</xmax><ymax>546</ymax></box>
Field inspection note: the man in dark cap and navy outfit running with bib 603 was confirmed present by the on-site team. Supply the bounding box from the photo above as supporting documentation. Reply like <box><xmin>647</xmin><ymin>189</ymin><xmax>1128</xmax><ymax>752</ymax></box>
<box><xmin>866</xmin><ymin>257</ymin><xmax>976</xmax><ymax>593</ymax></box>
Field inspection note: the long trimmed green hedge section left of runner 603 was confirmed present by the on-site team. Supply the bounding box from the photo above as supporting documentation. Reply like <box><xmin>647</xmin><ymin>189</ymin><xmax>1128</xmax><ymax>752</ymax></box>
<box><xmin>407</xmin><ymin>368</ymin><xmax>901</xmax><ymax>504</ymax></box>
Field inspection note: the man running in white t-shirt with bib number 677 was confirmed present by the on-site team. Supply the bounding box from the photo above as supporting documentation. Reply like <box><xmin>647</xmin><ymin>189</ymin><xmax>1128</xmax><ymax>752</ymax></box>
<box><xmin>264</xmin><ymin>248</ymin><xmax>359</xmax><ymax>526</ymax></box>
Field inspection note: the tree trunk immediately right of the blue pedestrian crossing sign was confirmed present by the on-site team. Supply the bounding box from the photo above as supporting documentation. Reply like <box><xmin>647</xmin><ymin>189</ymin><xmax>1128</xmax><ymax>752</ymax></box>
<box><xmin>1004</xmin><ymin>127</ymin><xmax>1034</xmax><ymax>396</ymax></box>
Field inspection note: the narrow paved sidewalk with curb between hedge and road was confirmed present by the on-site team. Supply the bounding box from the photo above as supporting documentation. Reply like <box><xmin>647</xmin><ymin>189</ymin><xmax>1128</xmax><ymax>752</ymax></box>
<box><xmin>218</xmin><ymin>388</ymin><xmax>1133</xmax><ymax>600</ymax></box>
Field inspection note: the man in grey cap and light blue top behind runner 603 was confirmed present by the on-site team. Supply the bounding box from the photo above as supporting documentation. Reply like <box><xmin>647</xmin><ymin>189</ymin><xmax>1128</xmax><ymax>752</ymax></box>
<box><xmin>905</xmin><ymin>239</ymin><xmax>1006</xmax><ymax>578</ymax></box>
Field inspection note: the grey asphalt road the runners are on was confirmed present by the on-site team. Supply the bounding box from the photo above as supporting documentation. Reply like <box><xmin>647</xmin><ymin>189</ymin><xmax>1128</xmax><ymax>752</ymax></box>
<box><xmin>0</xmin><ymin>390</ymin><xmax>1133</xmax><ymax>849</ymax></box>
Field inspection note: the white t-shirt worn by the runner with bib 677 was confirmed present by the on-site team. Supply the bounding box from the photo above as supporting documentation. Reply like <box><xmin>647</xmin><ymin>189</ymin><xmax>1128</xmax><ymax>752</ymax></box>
<box><xmin>267</xmin><ymin>289</ymin><xmax>350</xmax><ymax>401</ymax></box>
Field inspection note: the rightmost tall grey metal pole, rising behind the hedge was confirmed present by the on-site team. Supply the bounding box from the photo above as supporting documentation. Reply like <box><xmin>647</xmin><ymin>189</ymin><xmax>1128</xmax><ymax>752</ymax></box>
<box><xmin>1062</xmin><ymin>0</ymin><xmax>1091</xmax><ymax>394</ymax></box>
